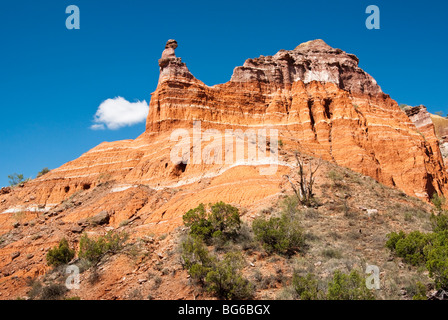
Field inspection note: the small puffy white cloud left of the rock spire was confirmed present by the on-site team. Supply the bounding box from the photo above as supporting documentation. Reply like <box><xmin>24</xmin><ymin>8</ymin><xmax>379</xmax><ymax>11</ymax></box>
<box><xmin>90</xmin><ymin>97</ymin><xmax>149</xmax><ymax>130</ymax></box>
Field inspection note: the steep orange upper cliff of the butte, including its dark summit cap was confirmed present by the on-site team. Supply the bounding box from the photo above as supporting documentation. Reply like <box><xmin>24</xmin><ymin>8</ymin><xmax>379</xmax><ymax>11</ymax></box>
<box><xmin>147</xmin><ymin>40</ymin><xmax>447</xmax><ymax>199</ymax></box>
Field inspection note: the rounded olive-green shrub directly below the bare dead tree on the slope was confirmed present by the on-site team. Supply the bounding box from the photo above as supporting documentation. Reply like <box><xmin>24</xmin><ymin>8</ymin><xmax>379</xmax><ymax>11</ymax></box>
<box><xmin>252</xmin><ymin>214</ymin><xmax>305</xmax><ymax>254</ymax></box>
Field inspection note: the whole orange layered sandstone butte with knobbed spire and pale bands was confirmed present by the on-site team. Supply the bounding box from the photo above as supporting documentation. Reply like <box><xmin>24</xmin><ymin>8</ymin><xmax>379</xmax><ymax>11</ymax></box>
<box><xmin>0</xmin><ymin>40</ymin><xmax>448</xmax><ymax>238</ymax></box>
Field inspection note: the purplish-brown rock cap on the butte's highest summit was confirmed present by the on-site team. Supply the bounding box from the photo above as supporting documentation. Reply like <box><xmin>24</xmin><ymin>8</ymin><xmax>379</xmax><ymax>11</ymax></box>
<box><xmin>231</xmin><ymin>40</ymin><xmax>382</xmax><ymax>95</ymax></box>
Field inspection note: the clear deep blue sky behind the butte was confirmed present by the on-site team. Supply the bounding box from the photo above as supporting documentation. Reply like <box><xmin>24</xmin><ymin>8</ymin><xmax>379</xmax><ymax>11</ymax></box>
<box><xmin>0</xmin><ymin>0</ymin><xmax>448</xmax><ymax>186</ymax></box>
